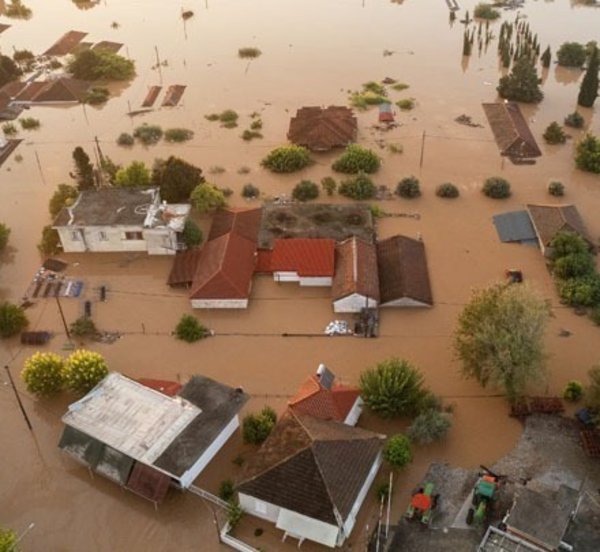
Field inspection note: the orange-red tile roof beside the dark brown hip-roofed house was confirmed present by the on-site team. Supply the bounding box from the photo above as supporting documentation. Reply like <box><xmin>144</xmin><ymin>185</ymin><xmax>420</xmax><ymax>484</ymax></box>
<box><xmin>288</xmin><ymin>374</ymin><xmax>360</xmax><ymax>422</ymax></box>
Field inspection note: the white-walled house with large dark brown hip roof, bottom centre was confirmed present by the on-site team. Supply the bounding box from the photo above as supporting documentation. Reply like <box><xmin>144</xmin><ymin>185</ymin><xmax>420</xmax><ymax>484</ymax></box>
<box><xmin>237</xmin><ymin>410</ymin><xmax>383</xmax><ymax>548</ymax></box>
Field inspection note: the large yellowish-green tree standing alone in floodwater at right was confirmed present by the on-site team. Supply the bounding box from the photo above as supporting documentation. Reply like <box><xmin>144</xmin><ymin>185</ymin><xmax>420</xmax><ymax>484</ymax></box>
<box><xmin>454</xmin><ymin>284</ymin><xmax>550</xmax><ymax>401</ymax></box>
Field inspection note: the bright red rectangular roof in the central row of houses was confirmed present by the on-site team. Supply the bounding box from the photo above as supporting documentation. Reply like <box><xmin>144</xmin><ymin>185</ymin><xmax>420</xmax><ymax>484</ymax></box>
<box><xmin>270</xmin><ymin>238</ymin><xmax>335</xmax><ymax>277</ymax></box>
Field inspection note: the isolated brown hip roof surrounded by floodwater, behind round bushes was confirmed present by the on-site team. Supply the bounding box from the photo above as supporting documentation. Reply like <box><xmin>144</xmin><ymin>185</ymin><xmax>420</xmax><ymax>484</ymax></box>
<box><xmin>288</xmin><ymin>105</ymin><xmax>357</xmax><ymax>151</ymax></box>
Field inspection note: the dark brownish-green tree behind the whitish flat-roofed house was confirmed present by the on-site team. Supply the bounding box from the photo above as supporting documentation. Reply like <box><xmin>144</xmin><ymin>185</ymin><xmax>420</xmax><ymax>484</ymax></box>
<box><xmin>152</xmin><ymin>156</ymin><xmax>204</xmax><ymax>203</ymax></box>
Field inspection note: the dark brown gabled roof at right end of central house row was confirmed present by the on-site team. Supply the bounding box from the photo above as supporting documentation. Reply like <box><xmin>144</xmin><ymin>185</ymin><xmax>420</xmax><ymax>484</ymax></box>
<box><xmin>377</xmin><ymin>235</ymin><xmax>433</xmax><ymax>306</ymax></box>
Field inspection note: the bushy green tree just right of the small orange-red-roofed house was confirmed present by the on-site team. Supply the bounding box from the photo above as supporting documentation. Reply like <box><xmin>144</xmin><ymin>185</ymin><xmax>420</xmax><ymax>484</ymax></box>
<box><xmin>359</xmin><ymin>358</ymin><xmax>429</xmax><ymax>418</ymax></box>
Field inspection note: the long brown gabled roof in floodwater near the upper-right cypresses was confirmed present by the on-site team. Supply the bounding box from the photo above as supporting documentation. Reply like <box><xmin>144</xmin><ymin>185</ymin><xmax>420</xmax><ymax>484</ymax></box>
<box><xmin>482</xmin><ymin>101</ymin><xmax>542</xmax><ymax>157</ymax></box>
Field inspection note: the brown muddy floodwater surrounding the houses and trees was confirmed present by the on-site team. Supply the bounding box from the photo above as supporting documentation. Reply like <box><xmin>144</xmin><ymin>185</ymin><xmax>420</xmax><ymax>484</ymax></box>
<box><xmin>0</xmin><ymin>0</ymin><xmax>600</xmax><ymax>552</ymax></box>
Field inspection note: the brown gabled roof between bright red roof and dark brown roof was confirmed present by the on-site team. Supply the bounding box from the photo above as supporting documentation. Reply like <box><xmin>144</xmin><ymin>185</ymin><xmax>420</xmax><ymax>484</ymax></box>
<box><xmin>333</xmin><ymin>236</ymin><xmax>379</xmax><ymax>301</ymax></box>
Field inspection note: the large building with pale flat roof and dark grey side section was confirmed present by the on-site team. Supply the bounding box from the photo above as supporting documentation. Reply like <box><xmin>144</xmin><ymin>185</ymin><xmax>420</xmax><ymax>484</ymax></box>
<box><xmin>58</xmin><ymin>372</ymin><xmax>248</xmax><ymax>503</ymax></box>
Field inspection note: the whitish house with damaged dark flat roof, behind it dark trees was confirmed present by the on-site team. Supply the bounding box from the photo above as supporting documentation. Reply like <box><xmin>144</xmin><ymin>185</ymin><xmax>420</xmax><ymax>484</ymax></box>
<box><xmin>53</xmin><ymin>188</ymin><xmax>190</xmax><ymax>255</ymax></box>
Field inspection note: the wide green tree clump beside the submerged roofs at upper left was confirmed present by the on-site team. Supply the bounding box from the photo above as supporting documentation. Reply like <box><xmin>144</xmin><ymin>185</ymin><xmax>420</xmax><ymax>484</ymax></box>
<box><xmin>68</xmin><ymin>49</ymin><xmax>135</xmax><ymax>81</ymax></box>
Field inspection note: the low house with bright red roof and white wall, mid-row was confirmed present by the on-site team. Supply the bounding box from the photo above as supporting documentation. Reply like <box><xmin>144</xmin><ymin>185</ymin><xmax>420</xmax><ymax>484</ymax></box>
<box><xmin>257</xmin><ymin>238</ymin><xmax>335</xmax><ymax>286</ymax></box>
